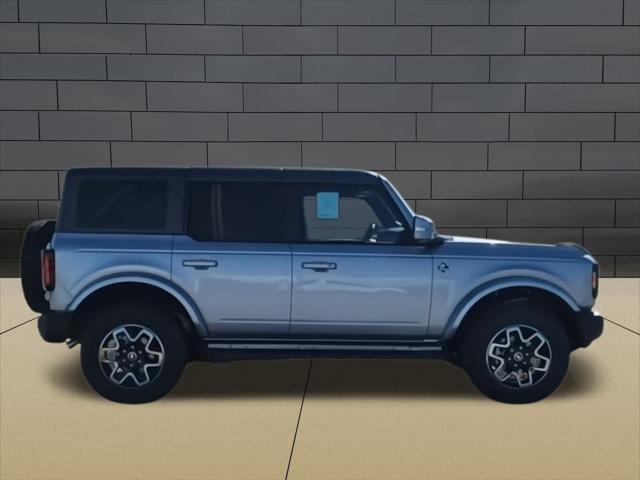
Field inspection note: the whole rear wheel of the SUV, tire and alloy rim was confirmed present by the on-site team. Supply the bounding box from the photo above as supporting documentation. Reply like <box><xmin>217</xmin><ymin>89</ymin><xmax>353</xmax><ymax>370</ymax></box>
<box><xmin>81</xmin><ymin>304</ymin><xmax>187</xmax><ymax>403</ymax></box>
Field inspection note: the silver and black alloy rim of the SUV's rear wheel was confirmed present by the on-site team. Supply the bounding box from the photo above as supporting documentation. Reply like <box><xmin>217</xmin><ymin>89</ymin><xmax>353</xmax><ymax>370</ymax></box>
<box><xmin>98</xmin><ymin>324</ymin><xmax>165</xmax><ymax>387</ymax></box>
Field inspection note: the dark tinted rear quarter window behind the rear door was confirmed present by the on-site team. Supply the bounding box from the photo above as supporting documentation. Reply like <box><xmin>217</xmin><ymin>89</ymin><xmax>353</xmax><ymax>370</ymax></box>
<box><xmin>73</xmin><ymin>178</ymin><xmax>168</xmax><ymax>233</ymax></box>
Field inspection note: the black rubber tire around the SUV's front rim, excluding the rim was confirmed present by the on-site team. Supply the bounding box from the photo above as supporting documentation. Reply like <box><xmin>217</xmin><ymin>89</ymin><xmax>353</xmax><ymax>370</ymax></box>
<box><xmin>459</xmin><ymin>302</ymin><xmax>571</xmax><ymax>403</ymax></box>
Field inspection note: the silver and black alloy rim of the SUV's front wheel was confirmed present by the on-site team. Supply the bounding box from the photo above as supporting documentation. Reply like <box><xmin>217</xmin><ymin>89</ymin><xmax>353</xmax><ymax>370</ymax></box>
<box><xmin>486</xmin><ymin>325</ymin><xmax>551</xmax><ymax>388</ymax></box>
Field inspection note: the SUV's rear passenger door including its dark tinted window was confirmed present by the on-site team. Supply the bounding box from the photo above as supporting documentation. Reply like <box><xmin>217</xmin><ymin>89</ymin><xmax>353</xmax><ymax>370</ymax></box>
<box><xmin>172</xmin><ymin>180</ymin><xmax>291</xmax><ymax>337</ymax></box>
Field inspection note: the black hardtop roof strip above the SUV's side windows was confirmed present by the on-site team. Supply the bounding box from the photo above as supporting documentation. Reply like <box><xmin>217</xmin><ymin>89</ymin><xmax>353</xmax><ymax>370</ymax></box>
<box><xmin>67</xmin><ymin>167</ymin><xmax>380</xmax><ymax>185</ymax></box>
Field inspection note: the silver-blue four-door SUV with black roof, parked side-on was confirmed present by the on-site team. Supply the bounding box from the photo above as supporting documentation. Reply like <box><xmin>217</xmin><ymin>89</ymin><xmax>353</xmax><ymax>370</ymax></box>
<box><xmin>22</xmin><ymin>169</ymin><xmax>603</xmax><ymax>403</ymax></box>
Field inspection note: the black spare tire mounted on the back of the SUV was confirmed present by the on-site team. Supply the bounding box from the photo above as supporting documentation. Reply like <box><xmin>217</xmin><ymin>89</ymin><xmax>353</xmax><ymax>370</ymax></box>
<box><xmin>20</xmin><ymin>220</ymin><xmax>56</xmax><ymax>313</ymax></box>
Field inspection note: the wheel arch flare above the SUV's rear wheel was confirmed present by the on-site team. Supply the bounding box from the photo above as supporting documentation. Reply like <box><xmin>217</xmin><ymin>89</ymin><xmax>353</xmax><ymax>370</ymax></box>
<box><xmin>71</xmin><ymin>280</ymin><xmax>206</xmax><ymax>339</ymax></box>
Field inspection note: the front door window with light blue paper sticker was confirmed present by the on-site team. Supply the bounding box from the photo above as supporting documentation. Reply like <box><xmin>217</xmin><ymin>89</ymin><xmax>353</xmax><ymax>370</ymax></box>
<box><xmin>302</xmin><ymin>185</ymin><xmax>407</xmax><ymax>244</ymax></box>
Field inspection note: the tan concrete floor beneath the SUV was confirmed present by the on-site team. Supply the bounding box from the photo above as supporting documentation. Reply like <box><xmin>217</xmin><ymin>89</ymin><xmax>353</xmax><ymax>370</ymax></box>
<box><xmin>0</xmin><ymin>279</ymin><xmax>640</xmax><ymax>480</ymax></box>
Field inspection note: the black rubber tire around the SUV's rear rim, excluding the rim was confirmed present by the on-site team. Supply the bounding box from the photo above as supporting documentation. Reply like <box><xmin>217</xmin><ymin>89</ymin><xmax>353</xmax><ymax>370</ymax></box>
<box><xmin>81</xmin><ymin>303</ymin><xmax>188</xmax><ymax>403</ymax></box>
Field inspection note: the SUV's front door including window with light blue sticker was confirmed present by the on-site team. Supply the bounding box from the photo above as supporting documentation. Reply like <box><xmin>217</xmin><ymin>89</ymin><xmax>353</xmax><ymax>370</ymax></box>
<box><xmin>291</xmin><ymin>185</ymin><xmax>432</xmax><ymax>340</ymax></box>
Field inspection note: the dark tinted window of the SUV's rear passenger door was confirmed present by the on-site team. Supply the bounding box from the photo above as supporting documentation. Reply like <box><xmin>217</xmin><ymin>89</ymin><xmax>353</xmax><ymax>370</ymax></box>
<box><xmin>187</xmin><ymin>181</ymin><xmax>293</xmax><ymax>243</ymax></box>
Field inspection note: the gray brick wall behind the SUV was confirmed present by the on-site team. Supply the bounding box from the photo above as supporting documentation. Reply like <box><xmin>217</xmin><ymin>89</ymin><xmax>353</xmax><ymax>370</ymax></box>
<box><xmin>0</xmin><ymin>0</ymin><xmax>640</xmax><ymax>276</ymax></box>
